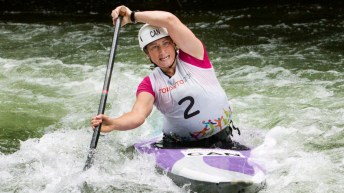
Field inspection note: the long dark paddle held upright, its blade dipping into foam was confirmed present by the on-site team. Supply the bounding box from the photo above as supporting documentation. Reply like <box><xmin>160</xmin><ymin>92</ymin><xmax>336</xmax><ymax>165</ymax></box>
<box><xmin>84</xmin><ymin>16</ymin><xmax>122</xmax><ymax>171</ymax></box>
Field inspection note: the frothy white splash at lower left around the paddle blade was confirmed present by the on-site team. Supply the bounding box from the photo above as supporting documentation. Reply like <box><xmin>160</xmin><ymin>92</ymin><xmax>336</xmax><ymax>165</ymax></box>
<box><xmin>0</xmin><ymin>129</ymin><xmax>185</xmax><ymax>192</ymax></box>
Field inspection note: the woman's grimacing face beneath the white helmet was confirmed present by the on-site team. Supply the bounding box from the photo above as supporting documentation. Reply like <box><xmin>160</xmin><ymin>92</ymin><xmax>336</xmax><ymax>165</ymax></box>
<box><xmin>147</xmin><ymin>37</ymin><xmax>176</xmax><ymax>69</ymax></box>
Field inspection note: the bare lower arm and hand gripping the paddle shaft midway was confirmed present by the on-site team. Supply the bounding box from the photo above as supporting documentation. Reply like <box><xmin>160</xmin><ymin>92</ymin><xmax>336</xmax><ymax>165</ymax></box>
<box><xmin>91</xmin><ymin>92</ymin><xmax>154</xmax><ymax>132</ymax></box>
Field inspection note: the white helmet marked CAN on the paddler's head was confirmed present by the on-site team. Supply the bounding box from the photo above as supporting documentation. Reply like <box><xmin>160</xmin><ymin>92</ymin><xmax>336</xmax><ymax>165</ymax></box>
<box><xmin>139</xmin><ymin>24</ymin><xmax>169</xmax><ymax>50</ymax></box>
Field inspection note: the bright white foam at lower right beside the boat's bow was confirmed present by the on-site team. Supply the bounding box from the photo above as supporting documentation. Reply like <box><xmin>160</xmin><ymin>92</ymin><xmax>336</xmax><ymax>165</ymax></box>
<box><xmin>252</xmin><ymin>127</ymin><xmax>343</xmax><ymax>193</ymax></box>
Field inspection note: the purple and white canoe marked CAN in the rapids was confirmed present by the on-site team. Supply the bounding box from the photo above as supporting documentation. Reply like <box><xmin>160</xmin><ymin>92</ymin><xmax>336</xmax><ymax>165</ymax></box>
<box><xmin>134</xmin><ymin>137</ymin><xmax>266</xmax><ymax>192</ymax></box>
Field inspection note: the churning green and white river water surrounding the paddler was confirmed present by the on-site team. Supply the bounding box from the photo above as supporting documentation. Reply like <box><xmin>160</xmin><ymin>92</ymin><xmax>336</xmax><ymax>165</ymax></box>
<box><xmin>0</xmin><ymin>5</ymin><xmax>344</xmax><ymax>193</ymax></box>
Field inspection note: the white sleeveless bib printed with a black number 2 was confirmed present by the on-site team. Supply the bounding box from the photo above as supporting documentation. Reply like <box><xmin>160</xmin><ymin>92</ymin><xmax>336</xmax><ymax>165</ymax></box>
<box><xmin>149</xmin><ymin>50</ymin><xmax>231</xmax><ymax>141</ymax></box>
